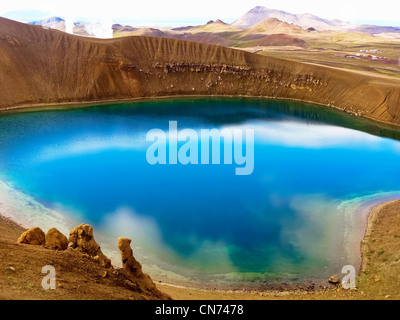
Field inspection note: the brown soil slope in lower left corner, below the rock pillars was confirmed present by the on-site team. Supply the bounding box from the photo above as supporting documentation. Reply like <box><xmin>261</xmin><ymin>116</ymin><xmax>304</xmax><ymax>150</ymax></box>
<box><xmin>0</xmin><ymin>215</ymin><xmax>170</xmax><ymax>300</ymax></box>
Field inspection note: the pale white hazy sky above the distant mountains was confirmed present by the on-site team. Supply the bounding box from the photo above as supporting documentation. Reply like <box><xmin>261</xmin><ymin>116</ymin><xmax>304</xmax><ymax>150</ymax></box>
<box><xmin>0</xmin><ymin>0</ymin><xmax>400</xmax><ymax>26</ymax></box>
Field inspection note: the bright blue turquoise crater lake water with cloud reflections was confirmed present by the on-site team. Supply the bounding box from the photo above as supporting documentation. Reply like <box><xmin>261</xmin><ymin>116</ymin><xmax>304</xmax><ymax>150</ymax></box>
<box><xmin>0</xmin><ymin>99</ymin><xmax>400</xmax><ymax>283</ymax></box>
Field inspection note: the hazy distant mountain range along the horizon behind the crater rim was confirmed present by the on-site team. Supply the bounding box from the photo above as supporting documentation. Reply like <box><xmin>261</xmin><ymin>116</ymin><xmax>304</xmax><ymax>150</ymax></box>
<box><xmin>29</xmin><ymin>6</ymin><xmax>400</xmax><ymax>48</ymax></box>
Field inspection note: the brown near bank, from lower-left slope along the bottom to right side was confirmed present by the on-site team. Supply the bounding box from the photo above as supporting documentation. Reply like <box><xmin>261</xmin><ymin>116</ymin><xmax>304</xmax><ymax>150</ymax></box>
<box><xmin>0</xmin><ymin>200</ymin><xmax>400</xmax><ymax>300</ymax></box>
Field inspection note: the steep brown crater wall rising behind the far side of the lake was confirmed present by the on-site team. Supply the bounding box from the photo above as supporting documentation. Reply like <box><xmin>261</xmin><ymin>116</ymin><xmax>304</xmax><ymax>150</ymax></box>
<box><xmin>0</xmin><ymin>18</ymin><xmax>400</xmax><ymax>124</ymax></box>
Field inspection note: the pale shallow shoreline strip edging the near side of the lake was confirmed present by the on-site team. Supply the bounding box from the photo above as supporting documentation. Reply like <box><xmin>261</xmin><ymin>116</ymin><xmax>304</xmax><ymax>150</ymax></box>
<box><xmin>0</xmin><ymin>175</ymin><xmax>400</xmax><ymax>294</ymax></box>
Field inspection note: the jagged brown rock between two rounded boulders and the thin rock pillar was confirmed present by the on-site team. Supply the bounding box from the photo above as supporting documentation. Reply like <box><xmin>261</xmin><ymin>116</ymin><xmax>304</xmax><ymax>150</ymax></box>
<box><xmin>67</xmin><ymin>223</ymin><xmax>111</xmax><ymax>267</ymax></box>
